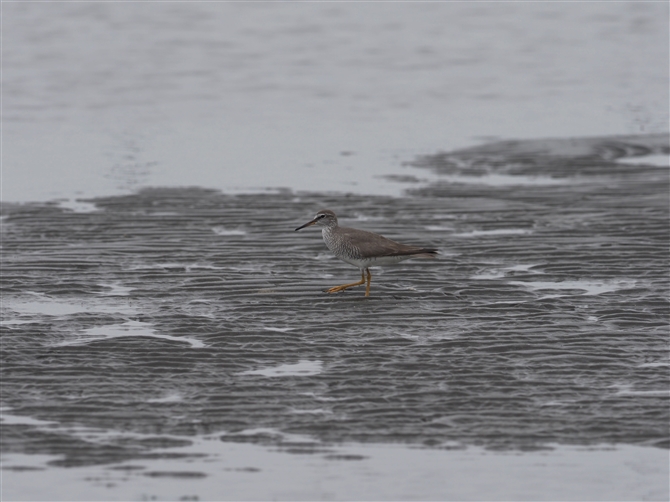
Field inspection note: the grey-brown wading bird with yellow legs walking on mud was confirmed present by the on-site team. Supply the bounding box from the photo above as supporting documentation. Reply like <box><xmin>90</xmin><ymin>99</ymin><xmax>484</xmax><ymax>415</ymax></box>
<box><xmin>295</xmin><ymin>209</ymin><xmax>437</xmax><ymax>296</ymax></box>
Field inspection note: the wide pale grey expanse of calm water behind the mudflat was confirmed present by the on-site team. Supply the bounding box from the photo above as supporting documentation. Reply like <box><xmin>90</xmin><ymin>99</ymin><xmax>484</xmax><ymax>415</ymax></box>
<box><xmin>2</xmin><ymin>2</ymin><xmax>669</xmax><ymax>201</ymax></box>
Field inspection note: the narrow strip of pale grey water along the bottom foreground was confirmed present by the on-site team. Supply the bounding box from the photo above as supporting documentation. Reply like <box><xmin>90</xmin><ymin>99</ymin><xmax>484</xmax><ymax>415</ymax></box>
<box><xmin>3</xmin><ymin>436</ymin><xmax>668</xmax><ymax>502</ymax></box>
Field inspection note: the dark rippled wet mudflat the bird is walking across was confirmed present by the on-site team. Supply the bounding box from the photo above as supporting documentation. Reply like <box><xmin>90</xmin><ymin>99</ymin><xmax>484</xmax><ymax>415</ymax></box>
<box><xmin>2</xmin><ymin>135</ymin><xmax>670</xmax><ymax>500</ymax></box>
